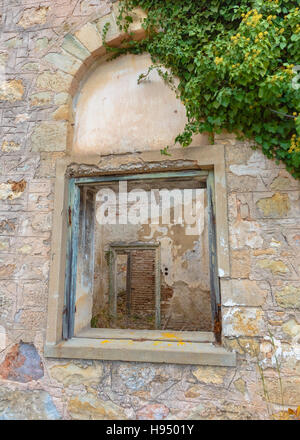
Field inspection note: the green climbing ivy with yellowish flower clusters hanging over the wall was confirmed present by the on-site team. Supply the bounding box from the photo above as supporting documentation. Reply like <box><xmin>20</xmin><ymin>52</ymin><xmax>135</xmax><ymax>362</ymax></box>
<box><xmin>108</xmin><ymin>0</ymin><xmax>300</xmax><ymax>179</ymax></box>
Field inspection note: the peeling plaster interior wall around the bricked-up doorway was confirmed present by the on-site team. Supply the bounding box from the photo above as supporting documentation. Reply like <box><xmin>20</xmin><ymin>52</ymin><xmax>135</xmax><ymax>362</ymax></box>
<box><xmin>93</xmin><ymin>187</ymin><xmax>212</xmax><ymax>331</ymax></box>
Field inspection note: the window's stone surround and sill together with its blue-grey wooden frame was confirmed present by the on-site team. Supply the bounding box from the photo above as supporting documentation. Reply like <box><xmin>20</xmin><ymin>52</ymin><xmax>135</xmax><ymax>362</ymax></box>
<box><xmin>45</xmin><ymin>145</ymin><xmax>236</xmax><ymax>366</ymax></box>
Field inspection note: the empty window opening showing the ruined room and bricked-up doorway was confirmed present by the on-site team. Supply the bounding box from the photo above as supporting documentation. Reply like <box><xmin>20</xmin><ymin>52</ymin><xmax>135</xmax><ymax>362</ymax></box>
<box><xmin>65</xmin><ymin>171</ymin><xmax>218</xmax><ymax>335</ymax></box>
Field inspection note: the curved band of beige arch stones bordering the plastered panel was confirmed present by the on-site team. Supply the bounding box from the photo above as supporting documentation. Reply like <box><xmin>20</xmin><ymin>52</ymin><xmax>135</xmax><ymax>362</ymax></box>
<box><xmin>40</xmin><ymin>2</ymin><xmax>146</xmax><ymax>154</ymax></box>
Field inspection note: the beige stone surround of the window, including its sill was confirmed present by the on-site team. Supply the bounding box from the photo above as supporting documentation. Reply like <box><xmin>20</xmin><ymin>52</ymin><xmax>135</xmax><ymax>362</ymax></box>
<box><xmin>45</xmin><ymin>145</ymin><xmax>236</xmax><ymax>366</ymax></box>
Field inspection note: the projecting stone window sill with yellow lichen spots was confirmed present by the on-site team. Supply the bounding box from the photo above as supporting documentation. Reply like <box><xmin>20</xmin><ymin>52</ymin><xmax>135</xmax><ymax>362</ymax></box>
<box><xmin>45</xmin><ymin>329</ymin><xmax>236</xmax><ymax>367</ymax></box>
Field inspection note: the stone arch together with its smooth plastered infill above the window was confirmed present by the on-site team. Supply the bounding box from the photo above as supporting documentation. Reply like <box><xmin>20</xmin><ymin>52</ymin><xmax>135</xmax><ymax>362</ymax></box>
<box><xmin>42</xmin><ymin>2</ymin><xmax>209</xmax><ymax>156</ymax></box>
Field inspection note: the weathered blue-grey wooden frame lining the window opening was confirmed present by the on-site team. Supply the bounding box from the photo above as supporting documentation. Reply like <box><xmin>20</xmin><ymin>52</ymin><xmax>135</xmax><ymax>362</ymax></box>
<box><xmin>63</xmin><ymin>170</ymin><xmax>221</xmax><ymax>336</ymax></box>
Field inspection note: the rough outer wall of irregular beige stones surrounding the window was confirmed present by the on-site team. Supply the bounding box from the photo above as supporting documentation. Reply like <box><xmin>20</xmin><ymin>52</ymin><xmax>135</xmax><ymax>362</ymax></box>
<box><xmin>0</xmin><ymin>0</ymin><xmax>300</xmax><ymax>419</ymax></box>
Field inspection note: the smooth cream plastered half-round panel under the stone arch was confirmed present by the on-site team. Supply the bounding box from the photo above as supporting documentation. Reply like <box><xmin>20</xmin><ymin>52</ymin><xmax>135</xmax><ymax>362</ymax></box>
<box><xmin>73</xmin><ymin>54</ymin><xmax>209</xmax><ymax>154</ymax></box>
